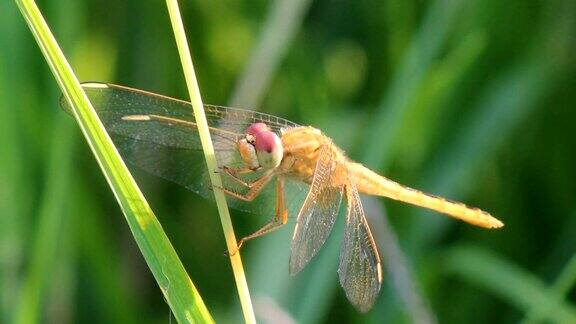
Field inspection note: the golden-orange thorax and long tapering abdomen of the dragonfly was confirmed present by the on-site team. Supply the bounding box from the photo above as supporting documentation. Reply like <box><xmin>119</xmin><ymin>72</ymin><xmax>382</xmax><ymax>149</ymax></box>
<box><xmin>280</xmin><ymin>126</ymin><xmax>503</xmax><ymax>228</ymax></box>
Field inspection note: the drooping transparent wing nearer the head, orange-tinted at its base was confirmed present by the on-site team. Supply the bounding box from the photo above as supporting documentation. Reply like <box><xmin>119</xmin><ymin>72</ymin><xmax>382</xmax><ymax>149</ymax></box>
<box><xmin>290</xmin><ymin>146</ymin><xmax>343</xmax><ymax>274</ymax></box>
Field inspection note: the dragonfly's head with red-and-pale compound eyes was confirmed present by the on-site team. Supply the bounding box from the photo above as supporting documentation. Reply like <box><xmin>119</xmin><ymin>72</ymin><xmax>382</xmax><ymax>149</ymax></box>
<box><xmin>238</xmin><ymin>123</ymin><xmax>284</xmax><ymax>169</ymax></box>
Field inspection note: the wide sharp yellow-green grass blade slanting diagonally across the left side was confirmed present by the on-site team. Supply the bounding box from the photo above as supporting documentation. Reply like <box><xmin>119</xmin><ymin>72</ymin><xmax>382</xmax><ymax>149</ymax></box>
<box><xmin>16</xmin><ymin>0</ymin><xmax>213</xmax><ymax>322</ymax></box>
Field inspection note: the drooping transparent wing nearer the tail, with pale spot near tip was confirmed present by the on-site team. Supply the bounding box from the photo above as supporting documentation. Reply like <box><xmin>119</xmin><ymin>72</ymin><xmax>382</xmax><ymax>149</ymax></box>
<box><xmin>338</xmin><ymin>183</ymin><xmax>382</xmax><ymax>312</ymax></box>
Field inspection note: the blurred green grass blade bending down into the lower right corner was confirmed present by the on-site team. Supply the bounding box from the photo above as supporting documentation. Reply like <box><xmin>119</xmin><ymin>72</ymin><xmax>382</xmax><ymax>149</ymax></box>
<box><xmin>448</xmin><ymin>245</ymin><xmax>576</xmax><ymax>323</ymax></box>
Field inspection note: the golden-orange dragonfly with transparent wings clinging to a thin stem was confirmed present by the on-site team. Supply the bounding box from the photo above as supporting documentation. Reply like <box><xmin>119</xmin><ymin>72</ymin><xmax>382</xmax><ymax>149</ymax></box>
<box><xmin>60</xmin><ymin>83</ymin><xmax>503</xmax><ymax>312</ymax></box>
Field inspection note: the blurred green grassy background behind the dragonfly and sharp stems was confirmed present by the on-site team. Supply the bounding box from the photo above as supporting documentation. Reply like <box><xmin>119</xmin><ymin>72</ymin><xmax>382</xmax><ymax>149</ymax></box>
<box><xmin>0</xmin><ymin>0</ymin><xmax>576</xmax><ymax>323</ymax></box>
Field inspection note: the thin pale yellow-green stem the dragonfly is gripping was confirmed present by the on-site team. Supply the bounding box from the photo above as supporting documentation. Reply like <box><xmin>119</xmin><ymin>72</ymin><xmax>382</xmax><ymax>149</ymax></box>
<box><xmin>166</xmin><ymin>0</ymin><xmax>256</xmax><ymax>323</ymax></box>
